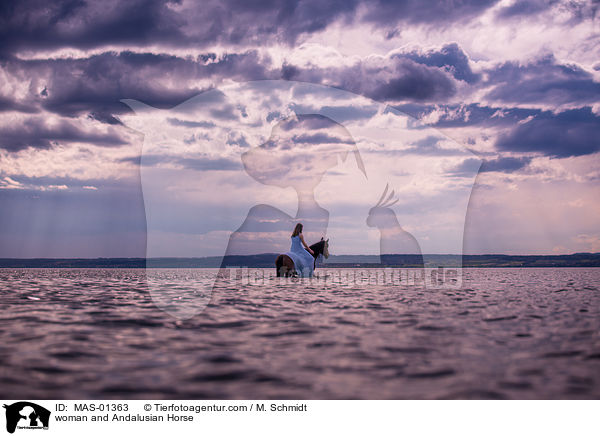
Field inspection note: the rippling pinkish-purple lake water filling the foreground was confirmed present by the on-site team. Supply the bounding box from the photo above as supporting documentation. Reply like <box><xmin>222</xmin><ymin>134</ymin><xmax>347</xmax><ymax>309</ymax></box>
<box><xmin>0</xmin><ymin>268</ymin><xmax>600</xmax><ymax>399</ymax></box>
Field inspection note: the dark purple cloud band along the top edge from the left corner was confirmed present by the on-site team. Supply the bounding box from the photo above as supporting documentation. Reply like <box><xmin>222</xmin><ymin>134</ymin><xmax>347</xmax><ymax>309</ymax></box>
<box><xmin>0</xmin><ymin>0</ymin><xmax>496</xmax><ymax>53</ymax></box>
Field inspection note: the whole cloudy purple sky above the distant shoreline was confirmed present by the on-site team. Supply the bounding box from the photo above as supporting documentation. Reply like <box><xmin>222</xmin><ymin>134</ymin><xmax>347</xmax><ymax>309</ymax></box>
<box><xmin>0</xmin><ymin>0</ymin><xmax>600</xmax><ymax>258</ymax></box>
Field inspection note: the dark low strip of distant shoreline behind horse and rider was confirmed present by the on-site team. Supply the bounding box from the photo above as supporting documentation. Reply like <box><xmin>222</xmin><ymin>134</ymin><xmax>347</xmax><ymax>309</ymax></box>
<box><xmin>0</xmin><ymin>253</ymin><xmax>600</xmax><ymax>268</ymax></box>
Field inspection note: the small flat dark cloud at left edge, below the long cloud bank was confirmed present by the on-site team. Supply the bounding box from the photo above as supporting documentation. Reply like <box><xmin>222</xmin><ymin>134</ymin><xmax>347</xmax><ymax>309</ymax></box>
<box><xmin>0</xmin><ymin>118</ymin><xmax>127</xmax><ymax>152</ymax></box>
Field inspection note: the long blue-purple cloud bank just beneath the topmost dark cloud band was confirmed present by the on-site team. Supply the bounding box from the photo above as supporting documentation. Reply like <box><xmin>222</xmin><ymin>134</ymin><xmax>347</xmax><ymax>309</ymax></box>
<box><xmin>0</xmin><ymin>44</ymin><xmax>478</xmax><ymax>124</ymax></box>
